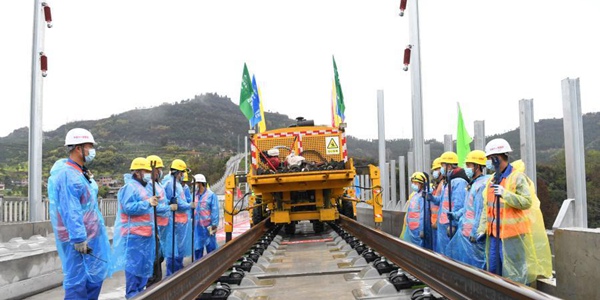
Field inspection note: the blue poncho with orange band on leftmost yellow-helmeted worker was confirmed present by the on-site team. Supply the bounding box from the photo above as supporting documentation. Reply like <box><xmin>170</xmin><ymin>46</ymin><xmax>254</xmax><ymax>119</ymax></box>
<box><xmin>110</xmin><ymin>174</ymin><xmax>156</xmax><ymax>277</ymax></box>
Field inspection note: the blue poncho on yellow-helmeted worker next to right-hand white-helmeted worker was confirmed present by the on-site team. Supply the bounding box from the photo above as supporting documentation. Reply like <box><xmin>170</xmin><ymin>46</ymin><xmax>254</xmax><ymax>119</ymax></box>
<box><xmin>446</xmin><ymin>175</ymin><xmax>490</xmax><ymax>269</ymax></box>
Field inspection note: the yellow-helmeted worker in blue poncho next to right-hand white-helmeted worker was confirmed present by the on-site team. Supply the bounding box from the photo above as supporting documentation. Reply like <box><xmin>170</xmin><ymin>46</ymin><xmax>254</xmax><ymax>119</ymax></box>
<box><xmin>446</xmin><ymin>150</ymin><xmax>490</xmax><ymax>269</ymax></box>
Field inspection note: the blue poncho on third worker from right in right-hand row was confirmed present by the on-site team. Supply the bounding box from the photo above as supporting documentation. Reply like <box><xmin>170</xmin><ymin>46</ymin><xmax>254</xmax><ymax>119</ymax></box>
<box><xmin>433</xmin><ymin>168</ymin><xmax>468</xmax><ymax>255</ymax></box>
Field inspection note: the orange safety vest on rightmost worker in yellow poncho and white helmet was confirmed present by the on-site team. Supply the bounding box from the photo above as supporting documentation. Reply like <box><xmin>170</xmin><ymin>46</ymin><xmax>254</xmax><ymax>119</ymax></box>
<box><xmin>486</xmin><ymin>168</ymin><xmax>531</xmax><ymax>239</ymax></box>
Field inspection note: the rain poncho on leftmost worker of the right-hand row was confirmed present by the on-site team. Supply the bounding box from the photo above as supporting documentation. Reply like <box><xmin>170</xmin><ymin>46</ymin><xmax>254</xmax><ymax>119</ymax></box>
<box><xmin>400</xmin><ymin>191</ymin><xmax>424</xmax><ymax>247</ymax></box>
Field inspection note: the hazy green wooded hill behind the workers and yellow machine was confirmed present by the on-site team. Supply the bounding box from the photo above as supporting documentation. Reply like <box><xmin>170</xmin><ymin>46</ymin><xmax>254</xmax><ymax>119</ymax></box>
<box><xmin>0</xmin><ymin>94</ymin><xmax>600</xmax><ymax>225</ymax></box>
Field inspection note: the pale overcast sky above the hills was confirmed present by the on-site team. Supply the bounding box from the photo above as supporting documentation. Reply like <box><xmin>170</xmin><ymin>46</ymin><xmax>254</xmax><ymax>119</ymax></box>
<box><xmin>0</xmin><ymin>0</ymin><xmax>600</xmax><ymax>140</ymax></box>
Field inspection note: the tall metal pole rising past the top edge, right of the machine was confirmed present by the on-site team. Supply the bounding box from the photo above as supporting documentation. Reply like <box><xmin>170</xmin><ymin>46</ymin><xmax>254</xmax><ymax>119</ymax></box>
<box><xmin>408</xmin><ymin>0</ymin><xmax>425</xmax><ymax>170</ymax></box>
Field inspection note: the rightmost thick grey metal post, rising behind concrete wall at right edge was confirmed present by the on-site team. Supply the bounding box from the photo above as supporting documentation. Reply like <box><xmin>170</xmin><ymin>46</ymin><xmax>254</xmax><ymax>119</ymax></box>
<box><xmin>562</xmin><ymin>78</ymin><xmax>588</xmax><ymax>228</ymax></box>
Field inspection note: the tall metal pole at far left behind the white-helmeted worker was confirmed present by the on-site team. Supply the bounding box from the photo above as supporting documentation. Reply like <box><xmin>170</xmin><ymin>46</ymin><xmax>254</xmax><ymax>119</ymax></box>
<box><xmin>28</xmin><ymin>0</ymin><xmax>45</xmax><ymax>222</ymax></box>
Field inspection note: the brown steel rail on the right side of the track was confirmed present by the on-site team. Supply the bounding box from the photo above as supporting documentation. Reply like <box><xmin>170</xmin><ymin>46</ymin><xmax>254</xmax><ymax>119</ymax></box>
<box><xmin>340</xmin><ymin>215</ymin><xmax>559</xmax><ymax>299</ymax></box>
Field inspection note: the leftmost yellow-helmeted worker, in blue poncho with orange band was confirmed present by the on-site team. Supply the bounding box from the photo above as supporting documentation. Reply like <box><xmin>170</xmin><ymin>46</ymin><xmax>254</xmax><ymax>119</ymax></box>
<box><xmin>110</xmin><ymin>157</ymin><xmax>158</xmax><ymax>299</ymax></box>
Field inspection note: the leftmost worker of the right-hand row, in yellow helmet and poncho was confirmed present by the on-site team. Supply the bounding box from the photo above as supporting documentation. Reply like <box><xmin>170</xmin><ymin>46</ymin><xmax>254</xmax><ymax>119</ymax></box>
<box><xmin>400</xmin><ymin>172</ymin><xmax>429</xmax><ymax>247</ymax></box>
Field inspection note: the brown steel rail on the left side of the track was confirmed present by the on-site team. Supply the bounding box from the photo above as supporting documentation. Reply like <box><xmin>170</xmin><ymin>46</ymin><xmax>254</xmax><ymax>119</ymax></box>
<box><xmin>134</xmin><ymin>218</ymin><xmax>268</xmax><ymax>300</ymax></box>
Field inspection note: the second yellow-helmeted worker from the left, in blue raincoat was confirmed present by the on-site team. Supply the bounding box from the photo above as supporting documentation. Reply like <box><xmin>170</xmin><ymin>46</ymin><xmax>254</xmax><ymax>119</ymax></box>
<box><xmin>146</xmin><ymin>155</ymin><xmax>171</xmax><ymax>287</ymax></box>
